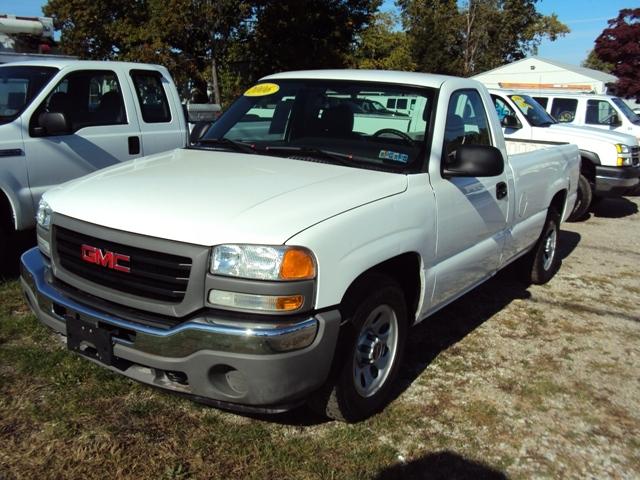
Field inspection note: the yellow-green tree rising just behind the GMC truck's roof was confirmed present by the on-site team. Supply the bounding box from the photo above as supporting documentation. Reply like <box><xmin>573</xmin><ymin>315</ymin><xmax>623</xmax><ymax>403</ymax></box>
<box><xmin>350</xmin><ymin>12</ymin><xmax>416</xmax><ymax>71</ymax></box>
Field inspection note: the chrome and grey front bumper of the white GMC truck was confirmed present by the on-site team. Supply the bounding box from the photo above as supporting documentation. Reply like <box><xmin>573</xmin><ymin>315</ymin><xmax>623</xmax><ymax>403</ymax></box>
<box><xmin>21</xmin><ymin>248</ymin><xmax>340</xmax><ymax>405</ymax></box>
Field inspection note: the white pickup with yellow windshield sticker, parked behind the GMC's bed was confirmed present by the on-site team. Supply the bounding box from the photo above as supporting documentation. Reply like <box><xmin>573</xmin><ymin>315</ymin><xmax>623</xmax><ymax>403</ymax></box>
<box><xmin>490</xmin><ymin>90</ymin><xmax>640</xmax><ymax>220</ymax></box>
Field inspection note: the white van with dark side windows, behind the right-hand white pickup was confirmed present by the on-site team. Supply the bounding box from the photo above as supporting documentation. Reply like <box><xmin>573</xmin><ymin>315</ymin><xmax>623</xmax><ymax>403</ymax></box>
<box><xmin>523</xmin><ymin>91</ymin><xmax>640</xmax><ymax>139</ymax></box>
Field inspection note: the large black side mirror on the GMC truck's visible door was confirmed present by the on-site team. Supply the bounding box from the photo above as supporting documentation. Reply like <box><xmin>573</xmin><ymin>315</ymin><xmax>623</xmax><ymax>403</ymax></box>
<box><xmin>443</xmin><ymin>145</ymin><xmax>504</xmax><ymax>178</ymax></box>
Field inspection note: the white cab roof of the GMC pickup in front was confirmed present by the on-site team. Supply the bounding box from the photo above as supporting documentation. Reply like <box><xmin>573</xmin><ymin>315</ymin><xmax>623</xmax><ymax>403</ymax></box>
<box><xmin>260</xmin><ymin>70</ymin><xmax>482</xmax><ymax>88</ymax></box>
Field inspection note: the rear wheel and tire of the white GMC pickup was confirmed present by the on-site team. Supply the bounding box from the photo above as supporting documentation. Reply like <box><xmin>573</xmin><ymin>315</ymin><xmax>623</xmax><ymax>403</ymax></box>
<box><xmin>522</xmin><ymin>207</ymin><xmax>561</xmax><ymax>285</ymax></box>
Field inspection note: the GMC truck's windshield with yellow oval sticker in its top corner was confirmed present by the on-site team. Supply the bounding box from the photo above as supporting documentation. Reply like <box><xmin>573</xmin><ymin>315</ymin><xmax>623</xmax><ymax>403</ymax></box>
<box><xmin>197</xmin><ymin>80</ymin><xmax>434</xmax><ymax>171</ymax></box>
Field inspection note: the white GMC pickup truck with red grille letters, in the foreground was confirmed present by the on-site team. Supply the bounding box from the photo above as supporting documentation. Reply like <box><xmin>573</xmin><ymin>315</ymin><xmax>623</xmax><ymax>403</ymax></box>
<box><xmin>22</xmin><ymin>70</ymin><xmax>579</xmax><ymax>421</ymax></box>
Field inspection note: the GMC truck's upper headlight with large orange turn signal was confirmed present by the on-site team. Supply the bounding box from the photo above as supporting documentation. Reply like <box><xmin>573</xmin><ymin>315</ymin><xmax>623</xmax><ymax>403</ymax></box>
<box><xmin>209</xmin><ymin>245</ymin><xmax>316</xmax><ymax>280</ymax></box>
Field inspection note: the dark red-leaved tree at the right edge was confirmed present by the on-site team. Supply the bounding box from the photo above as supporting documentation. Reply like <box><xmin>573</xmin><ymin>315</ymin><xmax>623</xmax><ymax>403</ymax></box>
<box><xmin>594</xmin><ymin>8</ymin><xmax>640</xmax><ymax>101</ymax></box>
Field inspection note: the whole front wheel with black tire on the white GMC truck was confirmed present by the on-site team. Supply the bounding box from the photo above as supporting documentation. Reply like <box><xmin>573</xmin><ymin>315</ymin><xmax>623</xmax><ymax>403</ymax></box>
<box><xmin>310</xmin><ymin>274</ymin><xmax>407</xmax><ymax>422</ymax></box>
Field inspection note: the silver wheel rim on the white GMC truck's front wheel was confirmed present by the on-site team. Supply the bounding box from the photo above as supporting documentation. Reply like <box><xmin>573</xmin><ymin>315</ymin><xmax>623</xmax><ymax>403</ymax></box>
<box><xmin>353</xmin><ymin>305</ymin><xmax>398</xmax><ymax>397</ymax></box>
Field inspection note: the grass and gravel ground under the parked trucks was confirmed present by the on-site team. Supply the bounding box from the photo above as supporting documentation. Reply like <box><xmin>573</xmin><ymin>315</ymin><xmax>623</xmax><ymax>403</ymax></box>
<box><xmin>0</xmin><ymin>197</ymin><xmax>640</xmax><ymax>480</ymax></box>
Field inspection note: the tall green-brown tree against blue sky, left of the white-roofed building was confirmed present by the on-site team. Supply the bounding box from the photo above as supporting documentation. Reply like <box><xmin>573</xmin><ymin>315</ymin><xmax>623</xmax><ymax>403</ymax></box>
<box><xmin>398</xmin><ymin>0</ymin><xmax>569</xmax><ymax>76</ymax></box>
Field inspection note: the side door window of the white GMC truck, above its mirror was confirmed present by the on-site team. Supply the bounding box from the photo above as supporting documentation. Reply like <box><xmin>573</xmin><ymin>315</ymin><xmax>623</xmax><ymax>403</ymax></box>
<box><xmin>442</xmin><ymin>90</ymin><xmax>491</xmax><ymax>162</ymax></box>
